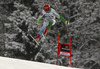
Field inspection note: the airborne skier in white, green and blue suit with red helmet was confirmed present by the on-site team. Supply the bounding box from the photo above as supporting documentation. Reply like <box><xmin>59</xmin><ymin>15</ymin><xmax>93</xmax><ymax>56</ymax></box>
<box><xmin>35</xmin><ymin>4</ymin><xmax>68</xmax><ymax>41</ymax></box>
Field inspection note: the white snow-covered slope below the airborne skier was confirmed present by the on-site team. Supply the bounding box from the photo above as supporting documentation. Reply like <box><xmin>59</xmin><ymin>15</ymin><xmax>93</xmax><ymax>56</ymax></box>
<box><xmin>0</xmin><ymin>57</ymin><xmax>81</xmax><ymax>69</ymax></box>
